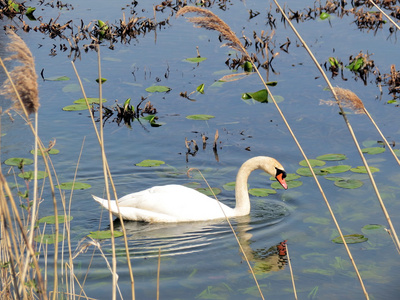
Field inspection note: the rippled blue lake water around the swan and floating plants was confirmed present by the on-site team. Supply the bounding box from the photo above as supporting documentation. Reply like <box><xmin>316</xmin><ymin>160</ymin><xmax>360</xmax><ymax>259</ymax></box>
<box><xmin>0</xmin><ymin>1</ymin><xmax>400</xmax><ymax>299</ymax></box>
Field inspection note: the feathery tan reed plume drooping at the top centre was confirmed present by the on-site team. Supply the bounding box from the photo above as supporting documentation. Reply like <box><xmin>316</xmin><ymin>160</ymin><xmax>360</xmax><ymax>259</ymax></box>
<box><xmin>176</xmin><ymin>6</ymin><xmax>249</xmax><ymax>57</ymax></box>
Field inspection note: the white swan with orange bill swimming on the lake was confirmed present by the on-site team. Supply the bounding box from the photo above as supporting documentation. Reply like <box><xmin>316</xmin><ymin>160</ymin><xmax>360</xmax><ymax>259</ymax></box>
<box><xmin>92</xmin><ymin>156</ymin><xmax>287</xmax><ymax>223</ymax></box>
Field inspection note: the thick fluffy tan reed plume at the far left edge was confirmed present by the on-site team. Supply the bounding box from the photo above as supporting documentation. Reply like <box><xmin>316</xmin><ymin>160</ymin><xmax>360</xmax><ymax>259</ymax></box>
<box><xmin>0</xmin><ymin>30</ymin><xmax>39</xmax><ymax>115</ymax></box>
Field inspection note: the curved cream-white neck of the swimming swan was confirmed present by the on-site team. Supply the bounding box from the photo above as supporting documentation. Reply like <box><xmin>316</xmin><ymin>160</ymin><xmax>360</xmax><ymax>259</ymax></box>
<box><xmin>235</xmin><ymin>156</ymin><xmax>275</xmax><ymax>216</ymax></box>
